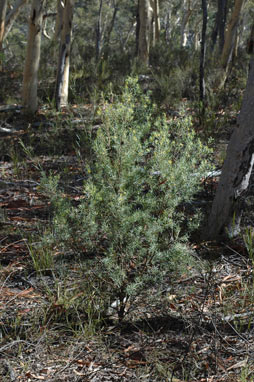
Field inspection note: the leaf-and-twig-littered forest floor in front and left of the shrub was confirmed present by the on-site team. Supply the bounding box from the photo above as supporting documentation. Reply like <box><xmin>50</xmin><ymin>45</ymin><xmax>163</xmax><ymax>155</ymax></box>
<box><xmin>0</xmin><ymin>106</ymin><xmax>254</xmax><ymax>382</ymax></box>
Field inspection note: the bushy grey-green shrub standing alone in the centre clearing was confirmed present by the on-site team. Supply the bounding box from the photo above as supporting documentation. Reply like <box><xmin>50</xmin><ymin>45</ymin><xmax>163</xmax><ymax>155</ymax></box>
<box><xmin>50</xmin><ymin>78</ymin><xmax>209</xmax><ymax>319</ymax></box>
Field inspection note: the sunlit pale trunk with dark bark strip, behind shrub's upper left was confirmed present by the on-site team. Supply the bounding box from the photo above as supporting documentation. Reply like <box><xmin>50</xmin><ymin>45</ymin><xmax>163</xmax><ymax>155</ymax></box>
<box><xmin>55</xmin><ymin>0</ymin><xmax>75</xmax><ymax>110</ymax></box>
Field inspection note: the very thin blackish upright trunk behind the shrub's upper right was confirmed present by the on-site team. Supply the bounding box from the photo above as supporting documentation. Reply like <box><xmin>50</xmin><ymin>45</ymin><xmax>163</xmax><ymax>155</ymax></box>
<box><xmin>199</xmin><ymin>0</ymin><xmax>207</xmax><ymax>115</ymax></box>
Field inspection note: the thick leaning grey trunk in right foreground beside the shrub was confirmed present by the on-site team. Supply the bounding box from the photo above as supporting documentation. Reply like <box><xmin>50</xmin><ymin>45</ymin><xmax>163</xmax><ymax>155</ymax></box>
<box><xmin>206</xmin><ymin>50</ymin><xmax>254</xmax><ymax>239</ymax></box>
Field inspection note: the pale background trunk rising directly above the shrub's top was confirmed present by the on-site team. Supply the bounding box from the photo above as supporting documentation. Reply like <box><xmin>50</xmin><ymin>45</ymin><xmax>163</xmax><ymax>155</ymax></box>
<box><xmin>138</xmin><ymin>0</ymin><xmax>152</xmax><ymax>66</ymax></box>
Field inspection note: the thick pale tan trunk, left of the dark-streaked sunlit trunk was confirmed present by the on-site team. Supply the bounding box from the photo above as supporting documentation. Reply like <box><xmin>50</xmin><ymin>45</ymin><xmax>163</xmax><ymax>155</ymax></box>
<box><xmin>22</xmin><ymin>0</ymin><xmax>45</xmax><ymax>113</ymax></box>
